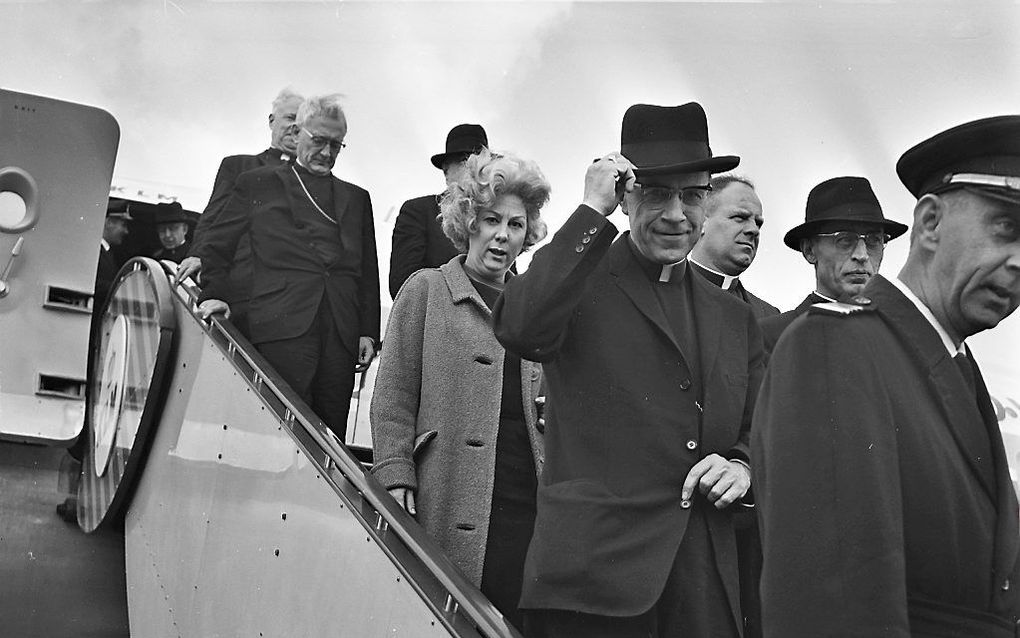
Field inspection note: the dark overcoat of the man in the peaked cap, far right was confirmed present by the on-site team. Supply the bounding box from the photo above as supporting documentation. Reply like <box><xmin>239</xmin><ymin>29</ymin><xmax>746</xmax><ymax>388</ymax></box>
<box><xmin>752</xmin><ymin>276</ymin><xmax>1020</xmax><ymax>638</ymax></box>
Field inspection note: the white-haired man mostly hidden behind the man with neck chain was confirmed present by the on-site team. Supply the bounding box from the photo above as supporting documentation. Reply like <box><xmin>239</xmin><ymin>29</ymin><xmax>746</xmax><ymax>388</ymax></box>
<box><xmin>177</xmin><ymin>88</ymin><xmax>304</xmax><ymax>336</ymax></box>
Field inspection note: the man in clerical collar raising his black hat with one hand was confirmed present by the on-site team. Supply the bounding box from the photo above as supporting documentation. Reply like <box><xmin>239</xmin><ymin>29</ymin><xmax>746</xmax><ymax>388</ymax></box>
<box><xmin>493</xmin><ymin>102</ymin><xmax>763</xmax><ymax>636</ymax></box>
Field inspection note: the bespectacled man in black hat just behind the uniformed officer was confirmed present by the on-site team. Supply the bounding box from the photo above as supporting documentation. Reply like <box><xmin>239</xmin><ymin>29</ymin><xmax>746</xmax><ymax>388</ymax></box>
<box><xmin>761</xmin><ymin>177</ymin><xmax>907</xmax><ymax>352</ymax></box>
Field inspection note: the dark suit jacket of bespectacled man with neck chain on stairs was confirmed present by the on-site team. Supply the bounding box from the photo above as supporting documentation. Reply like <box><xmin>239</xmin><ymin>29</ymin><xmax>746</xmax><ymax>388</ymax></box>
<box><xmin>201</xmin><ymin>164</ymin><xmax>379</xmax><ymax>355</ymax></box>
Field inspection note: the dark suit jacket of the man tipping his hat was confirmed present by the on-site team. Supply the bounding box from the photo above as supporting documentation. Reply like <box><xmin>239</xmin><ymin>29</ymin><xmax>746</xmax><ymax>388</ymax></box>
<box><xmin>493</xmin><ymin>206</ymin><xmax>763</xmax><ymax>626</ymax></box>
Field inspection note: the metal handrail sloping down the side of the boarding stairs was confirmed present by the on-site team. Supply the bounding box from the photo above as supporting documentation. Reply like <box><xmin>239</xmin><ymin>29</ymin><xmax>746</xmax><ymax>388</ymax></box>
<box><xmin>163</xmin><ymin>261</ymin><xmax>521</xmax><ymax>638</ymax></box>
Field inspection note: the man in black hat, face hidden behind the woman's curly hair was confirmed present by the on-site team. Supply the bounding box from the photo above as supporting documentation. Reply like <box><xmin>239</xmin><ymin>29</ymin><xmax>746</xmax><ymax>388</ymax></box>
<box><xmin>390</xmin><ymin>124</ymin><xmax>489</xmax><ymax>299</ymax></box>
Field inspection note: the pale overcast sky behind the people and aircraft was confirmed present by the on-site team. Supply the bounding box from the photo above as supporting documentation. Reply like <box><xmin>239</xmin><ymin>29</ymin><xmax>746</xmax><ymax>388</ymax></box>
<box><xmin>0</xmin><ymin>0</ymin><xmax>1020</xmax><ymax>375</ymax></box>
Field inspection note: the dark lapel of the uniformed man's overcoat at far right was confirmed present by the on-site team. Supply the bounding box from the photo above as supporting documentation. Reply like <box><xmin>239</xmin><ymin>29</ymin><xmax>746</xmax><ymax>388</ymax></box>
<box><xmin>864</xmin><ymin>275</ymin><xmax>1002</xmax><ymax>502</ymax></box>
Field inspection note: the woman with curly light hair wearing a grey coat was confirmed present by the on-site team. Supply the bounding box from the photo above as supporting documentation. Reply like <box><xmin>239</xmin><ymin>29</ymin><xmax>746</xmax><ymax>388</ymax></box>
<box><xmin>371</xmin><ymin>149</ymin><xmax>550</xmax><ymax>628</ymax></box>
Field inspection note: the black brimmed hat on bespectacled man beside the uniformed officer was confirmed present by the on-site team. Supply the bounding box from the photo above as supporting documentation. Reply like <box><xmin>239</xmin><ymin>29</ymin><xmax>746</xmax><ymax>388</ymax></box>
<box><xmin>782</xmin><ymin>177</ymin><xmax>907</xmax><ymax>251</ymax></box>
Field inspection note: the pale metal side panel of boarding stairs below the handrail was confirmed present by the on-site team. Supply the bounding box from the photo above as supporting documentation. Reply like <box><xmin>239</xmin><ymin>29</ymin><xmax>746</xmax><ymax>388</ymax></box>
<box><xmin>125</xmin><ymin>289</ymin><xmax>477</xmax><ymax>638</ymax></box>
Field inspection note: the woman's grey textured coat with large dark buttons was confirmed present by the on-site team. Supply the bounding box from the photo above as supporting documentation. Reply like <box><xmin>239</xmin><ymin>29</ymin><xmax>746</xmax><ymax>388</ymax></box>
<box><xmin>371</xmin><ymin>255</ymin><xmax>544</xmax><ymax>585</ymax></box>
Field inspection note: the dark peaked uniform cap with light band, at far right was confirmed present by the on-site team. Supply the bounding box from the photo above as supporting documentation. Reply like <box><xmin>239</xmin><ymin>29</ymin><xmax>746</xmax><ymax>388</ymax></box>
<box><xmin>896</xmin><ymin>115</ymin><xmax>1020</xmax><ymax>202</ymax></box>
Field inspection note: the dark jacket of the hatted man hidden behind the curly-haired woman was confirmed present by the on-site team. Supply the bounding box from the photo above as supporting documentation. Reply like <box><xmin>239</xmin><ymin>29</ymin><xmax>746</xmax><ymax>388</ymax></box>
<box><xmin>390</xmin><ymin>195</ymin><xmax>460</xmax><ymax>299</ymax></box>
